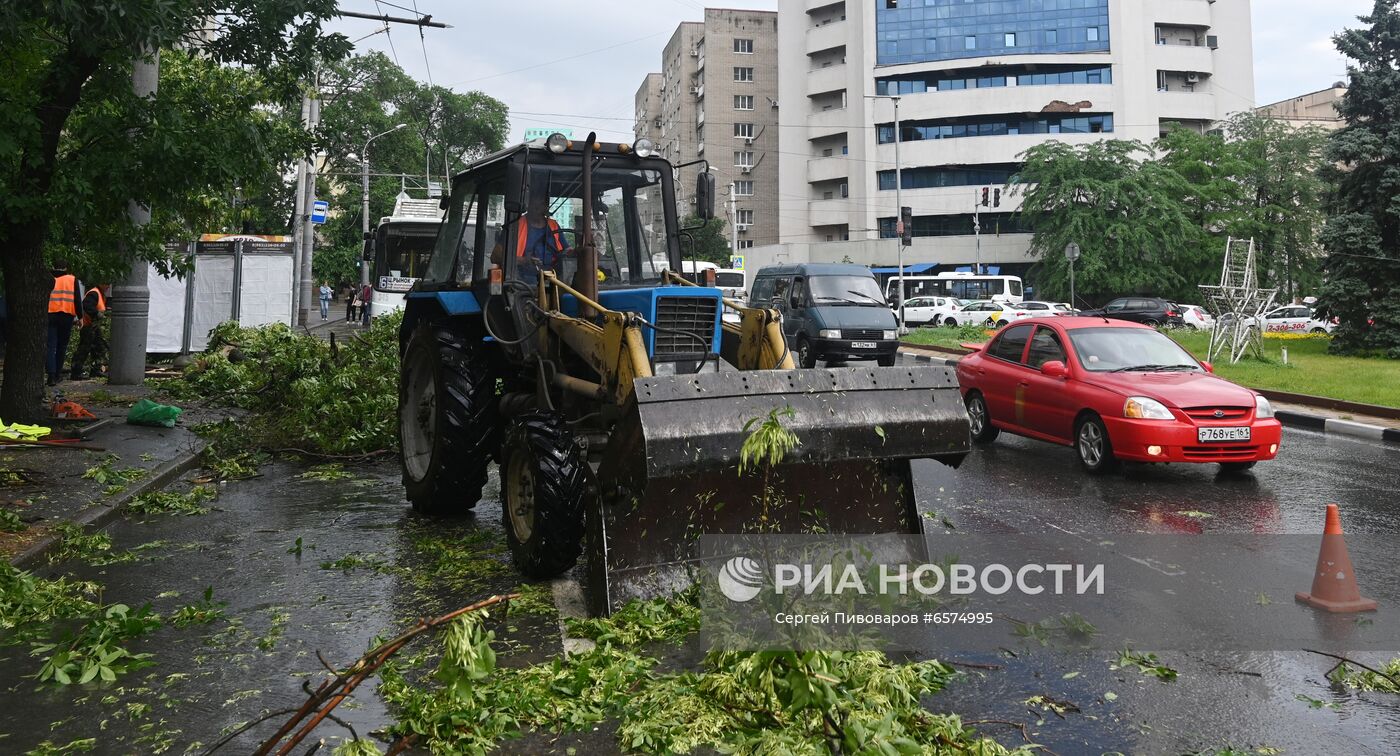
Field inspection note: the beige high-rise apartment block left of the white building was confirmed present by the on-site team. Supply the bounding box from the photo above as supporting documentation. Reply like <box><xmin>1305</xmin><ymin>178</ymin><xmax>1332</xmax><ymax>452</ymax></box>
<box><xmin>634</xmin><ymin>8</ymin><xmax>778</xmax><ymax>248</ymax></box>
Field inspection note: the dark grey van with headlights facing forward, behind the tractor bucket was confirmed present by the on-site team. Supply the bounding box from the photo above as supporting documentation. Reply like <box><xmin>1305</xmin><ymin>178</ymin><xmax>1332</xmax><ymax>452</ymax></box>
<box><xmin>749</xmin><ymin>263</ymin><xmax>899</xmax><ymax>368</ymax></box>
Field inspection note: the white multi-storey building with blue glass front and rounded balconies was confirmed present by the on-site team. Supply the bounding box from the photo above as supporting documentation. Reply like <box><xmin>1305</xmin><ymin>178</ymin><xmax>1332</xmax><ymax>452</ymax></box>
<box><xmin>778</xmin><ymin>0</ymin><xmax>1254</xmax><ymax>271</ymax></box>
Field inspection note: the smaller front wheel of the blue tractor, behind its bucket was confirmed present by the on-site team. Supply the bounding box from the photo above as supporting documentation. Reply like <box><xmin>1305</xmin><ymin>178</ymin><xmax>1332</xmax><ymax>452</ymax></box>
<box><xmin>501</xmin><ymin>412</ymin><xmax>588</xmax><ymax>580</ymax></box>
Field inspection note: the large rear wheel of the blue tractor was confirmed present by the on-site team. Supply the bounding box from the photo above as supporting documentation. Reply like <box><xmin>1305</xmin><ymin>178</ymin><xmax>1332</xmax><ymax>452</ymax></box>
<box><xmin>399</xmin><ymin>325</ymin><xmax>500</xmax><ymax>515</ymax></box>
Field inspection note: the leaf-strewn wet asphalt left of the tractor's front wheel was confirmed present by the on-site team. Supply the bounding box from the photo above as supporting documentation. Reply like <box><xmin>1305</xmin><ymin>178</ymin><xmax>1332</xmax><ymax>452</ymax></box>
<box><xmin>0</xmin><ymin>463</ymin><xmax>559</xmax><ymax>753</ymax></box>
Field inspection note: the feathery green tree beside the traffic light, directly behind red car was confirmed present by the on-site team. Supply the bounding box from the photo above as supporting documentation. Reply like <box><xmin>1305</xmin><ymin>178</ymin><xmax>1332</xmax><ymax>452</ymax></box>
<box><xmin>1014</xmin><ymin>140</ymin><xmax>1208</xmax><ymax>302</ymax></box>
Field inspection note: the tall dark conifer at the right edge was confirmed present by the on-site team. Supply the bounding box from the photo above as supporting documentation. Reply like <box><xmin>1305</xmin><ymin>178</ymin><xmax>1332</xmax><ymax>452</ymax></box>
<box><xmin>1319</xmin><ymin>0</ymin><xmax>1400</xmax><ymax>358</ymax></box>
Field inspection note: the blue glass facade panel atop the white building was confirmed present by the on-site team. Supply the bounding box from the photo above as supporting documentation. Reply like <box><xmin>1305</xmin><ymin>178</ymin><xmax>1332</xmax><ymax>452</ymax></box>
<box><xmin>874</xmin><ymin>0</ymin><xmax>1109</xmax><ymax>66</ymax></box>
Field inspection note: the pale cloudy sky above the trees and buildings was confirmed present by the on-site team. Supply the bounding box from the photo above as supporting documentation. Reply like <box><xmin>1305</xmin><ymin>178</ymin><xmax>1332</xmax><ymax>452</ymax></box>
<box><xmin>336</xmin><ymin>0</ymin><xmax>1372</xmax><ymax>141</ymax></box>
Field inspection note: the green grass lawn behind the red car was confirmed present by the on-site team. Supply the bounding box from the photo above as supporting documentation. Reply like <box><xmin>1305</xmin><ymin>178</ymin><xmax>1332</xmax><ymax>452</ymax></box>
<box><xmin>904</xmin><ymin>328</ymin><xmax>1400</xmax><ymax>407</ymax></box>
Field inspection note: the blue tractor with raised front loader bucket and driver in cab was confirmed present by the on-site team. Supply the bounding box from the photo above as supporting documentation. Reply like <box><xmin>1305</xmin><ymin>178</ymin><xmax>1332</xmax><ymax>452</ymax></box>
<box><xmin>399</xmin><ymin>134</ymin><xmax>969</xmax><ymax>613</ymax></box>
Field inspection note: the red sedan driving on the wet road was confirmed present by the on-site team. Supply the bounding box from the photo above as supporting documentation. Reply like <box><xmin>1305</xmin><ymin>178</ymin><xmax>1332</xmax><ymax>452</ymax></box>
<box><xmin>958</xmin><ymin>316</ymin><xmax>1282</xmax><ymax>473</ymax></box>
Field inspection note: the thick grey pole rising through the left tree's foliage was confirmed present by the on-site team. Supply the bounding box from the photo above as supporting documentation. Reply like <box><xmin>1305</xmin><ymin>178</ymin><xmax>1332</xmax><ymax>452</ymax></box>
<box><xmin>108</xmin><ymin>50</ymin><xmax>161</xmax><ymax>386</ymax></box>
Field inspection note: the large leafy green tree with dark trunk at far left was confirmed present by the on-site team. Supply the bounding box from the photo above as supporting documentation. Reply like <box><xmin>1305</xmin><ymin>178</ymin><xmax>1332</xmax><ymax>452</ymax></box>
<box><xmin>0</xmin><ymin>0</ymin><xmax>349</xmax><ymax>420</ymax></box>
